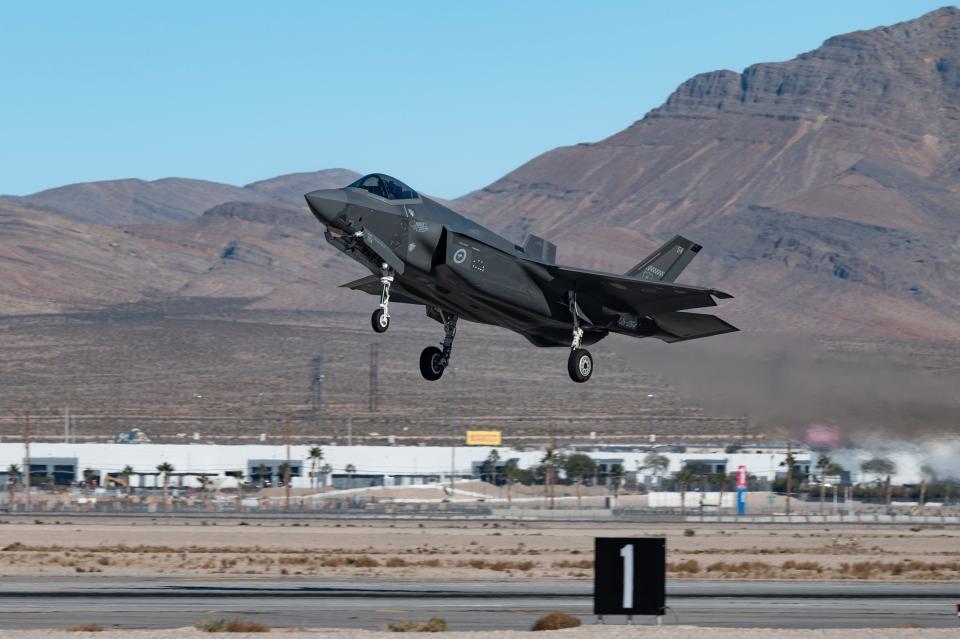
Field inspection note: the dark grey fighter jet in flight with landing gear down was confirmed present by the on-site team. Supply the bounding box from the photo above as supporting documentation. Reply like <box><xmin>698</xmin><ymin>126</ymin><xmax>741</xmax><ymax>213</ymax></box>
<box><xmin>305</xmin><ymin>173</ymin><xmax>737</xmax><ymax>382</ymax></box>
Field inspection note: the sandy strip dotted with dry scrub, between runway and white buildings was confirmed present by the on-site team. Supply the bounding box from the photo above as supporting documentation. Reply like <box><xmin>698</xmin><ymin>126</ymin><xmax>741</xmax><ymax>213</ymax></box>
<box><xmin>0</xmin><ymin>516</ymin><xmax>960</xmax><ymax>581</ymax></box>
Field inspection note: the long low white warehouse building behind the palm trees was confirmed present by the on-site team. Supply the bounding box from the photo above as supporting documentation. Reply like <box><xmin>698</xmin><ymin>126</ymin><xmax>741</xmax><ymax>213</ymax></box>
<box><xmin>0</xmin><ymin>443</ymin><xmax>811</xmax><ymax>488</ymax></box>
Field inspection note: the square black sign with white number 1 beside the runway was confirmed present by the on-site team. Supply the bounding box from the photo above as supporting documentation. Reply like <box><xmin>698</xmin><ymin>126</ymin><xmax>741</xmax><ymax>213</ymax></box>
<box><xmin>593</xmin><ymin>537</ymin><xmax>667</xmax><ymax>616</ymax></box>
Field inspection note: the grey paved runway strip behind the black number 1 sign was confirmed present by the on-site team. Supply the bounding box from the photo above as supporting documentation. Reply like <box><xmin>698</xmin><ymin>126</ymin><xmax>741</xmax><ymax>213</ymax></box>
<box><xmin>0</xmin><ymin>575</ymin><xmax>960</xmax><ymax>630</ymax></box>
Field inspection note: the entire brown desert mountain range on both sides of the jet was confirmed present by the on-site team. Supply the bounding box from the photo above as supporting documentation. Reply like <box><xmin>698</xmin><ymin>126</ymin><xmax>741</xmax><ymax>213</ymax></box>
<box><xmin>0</xmin><ymin>8</ymin><xmax>960</xmax><ymax>339</ymax></box>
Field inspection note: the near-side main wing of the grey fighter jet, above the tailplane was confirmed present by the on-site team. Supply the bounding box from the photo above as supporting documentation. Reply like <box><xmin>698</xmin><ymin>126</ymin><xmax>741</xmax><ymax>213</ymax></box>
<box><xmin>543</xmin><ymin>265</ymin><xmax>733</xmax><ymax>317</ymax></box>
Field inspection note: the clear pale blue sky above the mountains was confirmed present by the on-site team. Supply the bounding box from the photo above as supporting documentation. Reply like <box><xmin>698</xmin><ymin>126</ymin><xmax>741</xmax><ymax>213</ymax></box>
<box><xmin>0</xmin><ymin>0</ymin><xmax>944</xmax><ymax>197</ymax></box>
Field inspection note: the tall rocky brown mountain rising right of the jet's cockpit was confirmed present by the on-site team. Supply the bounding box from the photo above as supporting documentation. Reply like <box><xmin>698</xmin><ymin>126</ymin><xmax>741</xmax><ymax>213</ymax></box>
<box><xmin>456</xmin><ymin>8</ymin><xmax>960</xmax><ymax>338</ymax></box>
